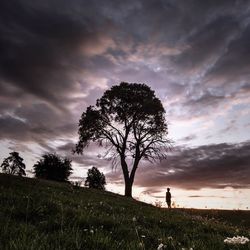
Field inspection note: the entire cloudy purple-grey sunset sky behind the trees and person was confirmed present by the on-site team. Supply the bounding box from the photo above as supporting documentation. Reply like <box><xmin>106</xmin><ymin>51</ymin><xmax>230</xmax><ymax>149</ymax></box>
<box><xmin>0</xmin><ymin>0</ymin><xmax>250</xmax><ymax>209</ymax></box>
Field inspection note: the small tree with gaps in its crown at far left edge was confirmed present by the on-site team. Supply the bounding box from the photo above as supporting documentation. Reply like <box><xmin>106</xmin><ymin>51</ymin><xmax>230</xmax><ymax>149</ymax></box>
<box><xmin>1</xmin><ymin>151</ymin><xmax>26</xmax><ymax>176</ymax></box>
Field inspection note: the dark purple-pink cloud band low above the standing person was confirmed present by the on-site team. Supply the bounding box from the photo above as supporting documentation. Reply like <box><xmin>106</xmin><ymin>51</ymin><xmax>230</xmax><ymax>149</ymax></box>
<box><xmin>133</xmin><ymin>141</ymin><xmax>250</xmax><ymax>189</ymax></box>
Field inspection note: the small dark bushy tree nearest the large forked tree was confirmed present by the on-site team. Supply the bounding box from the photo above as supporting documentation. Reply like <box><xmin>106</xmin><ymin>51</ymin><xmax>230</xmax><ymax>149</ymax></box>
<box><xmin>85</xmin><ymin>167</ymin><xmax>106</xmax><ymax>190</ymax></box>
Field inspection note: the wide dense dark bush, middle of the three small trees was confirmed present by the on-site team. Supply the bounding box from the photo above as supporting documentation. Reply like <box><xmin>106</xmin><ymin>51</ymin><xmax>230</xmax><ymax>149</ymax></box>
<box><xmin>33</xmin><ymin>154</ymin><xmax>72</xmax><ymax>181</ymax></box>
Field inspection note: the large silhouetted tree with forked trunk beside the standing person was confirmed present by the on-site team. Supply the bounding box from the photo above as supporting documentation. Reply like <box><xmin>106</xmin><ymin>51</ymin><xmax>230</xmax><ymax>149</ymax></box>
<box><xmin>75</xmin><ymin>82</ymin><xmax>169</xmax><ymax>197</ymax></box>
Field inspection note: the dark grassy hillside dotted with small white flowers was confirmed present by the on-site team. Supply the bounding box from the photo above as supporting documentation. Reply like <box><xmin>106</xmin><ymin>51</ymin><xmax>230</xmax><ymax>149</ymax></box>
<box><xmin>0</xmin><ymin>174</ymin><xmax>250</xmax><ymax>250</ymax></box>
